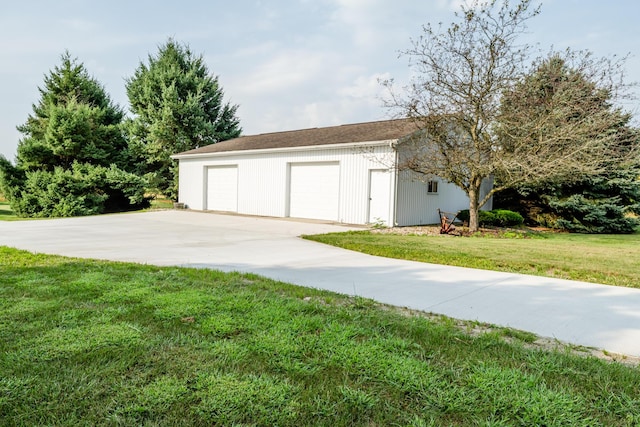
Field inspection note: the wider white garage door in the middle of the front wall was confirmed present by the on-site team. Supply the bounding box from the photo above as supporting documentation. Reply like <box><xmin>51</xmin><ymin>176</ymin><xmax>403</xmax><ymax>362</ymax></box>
<box><xmin>289</xmin><ymin>163</ymin><xmax>340</xmax><ymax>221</ymax></box>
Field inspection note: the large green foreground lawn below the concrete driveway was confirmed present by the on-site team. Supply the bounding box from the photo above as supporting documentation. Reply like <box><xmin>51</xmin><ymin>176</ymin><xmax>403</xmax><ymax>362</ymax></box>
<box><xmin>0</xmin><ymin>248</ymin><xmax>640</xmax><ymax>426</ymax></box>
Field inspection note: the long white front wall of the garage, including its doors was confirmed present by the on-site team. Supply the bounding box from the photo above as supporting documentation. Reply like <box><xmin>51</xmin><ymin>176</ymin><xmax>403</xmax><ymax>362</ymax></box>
<box><xmin>179</xmin><ymin>142</ymin><xmax>396</xmax><ymax>225</ymax></box>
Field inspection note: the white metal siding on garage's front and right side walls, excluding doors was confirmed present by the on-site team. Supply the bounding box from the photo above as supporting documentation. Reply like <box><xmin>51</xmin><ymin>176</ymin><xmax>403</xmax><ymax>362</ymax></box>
<box><xmin>179</xmin><ymin>145</ymin><xmax>490</xmax><ymax>226</ymax></box>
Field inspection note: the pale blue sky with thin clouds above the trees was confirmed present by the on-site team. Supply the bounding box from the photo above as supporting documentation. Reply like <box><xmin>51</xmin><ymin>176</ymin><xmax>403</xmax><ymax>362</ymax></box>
<box><xmin>0</xmin><ymin>0</ymin><xmax>640</xmax><ymax>161</ymax></box>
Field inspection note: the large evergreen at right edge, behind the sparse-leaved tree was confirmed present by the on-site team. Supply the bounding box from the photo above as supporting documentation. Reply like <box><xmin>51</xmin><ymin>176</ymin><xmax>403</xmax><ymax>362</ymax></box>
<box><xmin>496</xmin><ymin>55</ymin><xmax>640</xmax><ymax>233</ymax></box>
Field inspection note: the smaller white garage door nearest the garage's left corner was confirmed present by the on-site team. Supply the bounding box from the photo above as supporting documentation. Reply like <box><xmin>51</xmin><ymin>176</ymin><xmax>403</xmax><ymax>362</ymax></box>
<box><xmin>206</xmin><ymin>165</ymin><xmax>238</xmax><ymax>212</ymax></box>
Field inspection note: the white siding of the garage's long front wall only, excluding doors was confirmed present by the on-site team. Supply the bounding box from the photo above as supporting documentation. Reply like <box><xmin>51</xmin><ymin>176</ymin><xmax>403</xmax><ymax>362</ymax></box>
<box><xmin>179</xmin><ymin>144</ymin><xmax>395</xmax><ymax>225</ymax></box>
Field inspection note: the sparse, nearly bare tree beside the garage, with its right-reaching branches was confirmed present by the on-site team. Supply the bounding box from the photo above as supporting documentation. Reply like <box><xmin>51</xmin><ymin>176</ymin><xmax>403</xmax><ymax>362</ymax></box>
<box><xmin>387</xmin><ymin>0</ymin><xmax>630</xmax><ymax>231</ymax></box>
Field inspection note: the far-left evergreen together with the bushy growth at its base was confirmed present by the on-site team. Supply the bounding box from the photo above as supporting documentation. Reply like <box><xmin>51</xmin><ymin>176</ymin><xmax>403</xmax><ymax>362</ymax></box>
<box><xmin>0</xmin><ymin>53</ymin><xmax>146</xmax><ymax>217</ymax></box>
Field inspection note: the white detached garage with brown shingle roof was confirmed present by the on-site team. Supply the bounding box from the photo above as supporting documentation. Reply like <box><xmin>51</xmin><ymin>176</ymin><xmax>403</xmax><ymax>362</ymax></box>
<box><xmin>173</xmin><ymin>120</ymin><xmax>490</xmax><ymax>226</ymax></box>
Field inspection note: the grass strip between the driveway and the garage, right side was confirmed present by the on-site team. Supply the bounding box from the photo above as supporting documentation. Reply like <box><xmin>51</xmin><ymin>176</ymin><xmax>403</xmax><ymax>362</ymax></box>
<box><xmin>305</xmin><ymin>231</ymin><xmax>640</xmax><ymax>288</ymax></box>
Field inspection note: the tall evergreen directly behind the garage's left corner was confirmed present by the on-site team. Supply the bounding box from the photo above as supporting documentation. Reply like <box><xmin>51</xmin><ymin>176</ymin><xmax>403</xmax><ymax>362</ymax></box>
<box><xmin>126</xmin><ymin>39</ymin><xmax>241</xmax><ymax>200</ymax></box>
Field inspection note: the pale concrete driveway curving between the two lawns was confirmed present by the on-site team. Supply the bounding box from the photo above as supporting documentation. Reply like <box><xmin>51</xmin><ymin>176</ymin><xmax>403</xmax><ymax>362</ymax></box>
<box><xmin>0</xmin><ymin>211</ymin><xmax>640</xmax><ymax>356</ymax></box>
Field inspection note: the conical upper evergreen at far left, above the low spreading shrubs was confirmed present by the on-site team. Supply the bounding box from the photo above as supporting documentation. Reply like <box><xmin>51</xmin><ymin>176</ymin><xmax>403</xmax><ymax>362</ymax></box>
<box><xmin>16</xmin><ymin>52</ymin><xmax>128</xmax><ymax>170</ymax></box>
